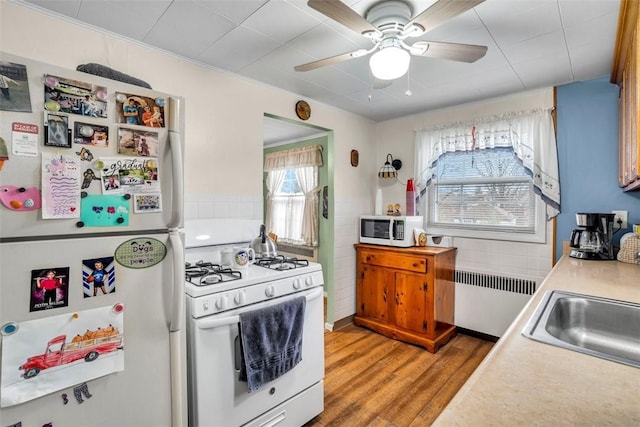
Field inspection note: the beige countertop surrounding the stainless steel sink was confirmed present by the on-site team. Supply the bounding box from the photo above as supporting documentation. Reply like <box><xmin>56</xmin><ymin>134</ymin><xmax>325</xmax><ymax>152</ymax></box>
<box><xmin>434</xmin><ymin>256</ymin><xmax>640</xmax><ymax>426</ymax></box>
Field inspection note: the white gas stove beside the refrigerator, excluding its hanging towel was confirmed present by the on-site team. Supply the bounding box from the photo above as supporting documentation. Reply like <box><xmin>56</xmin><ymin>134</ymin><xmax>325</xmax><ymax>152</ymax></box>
<box><xmin>185</xmin><ymin>220</ymin><xmax>324</xmax><ymax>427</ymax></box>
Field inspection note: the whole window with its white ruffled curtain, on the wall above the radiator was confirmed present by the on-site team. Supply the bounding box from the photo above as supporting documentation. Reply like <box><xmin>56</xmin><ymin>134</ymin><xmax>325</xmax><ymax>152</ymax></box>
<box><xmin>414</xmin><ymin>110</ymin><xmax>560</xmax><ymax>242</ymax></box>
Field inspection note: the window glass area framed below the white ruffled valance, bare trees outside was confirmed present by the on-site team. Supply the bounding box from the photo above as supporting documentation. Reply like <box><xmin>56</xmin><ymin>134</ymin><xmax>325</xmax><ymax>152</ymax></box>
<box><xmin>427</xmin><ymin>148</ymin><xmax>536</xmax><ymax>233</ymax></box>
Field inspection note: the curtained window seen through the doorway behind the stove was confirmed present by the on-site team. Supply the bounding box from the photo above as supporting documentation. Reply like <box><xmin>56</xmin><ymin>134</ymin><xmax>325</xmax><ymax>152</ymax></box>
<box><xmin>264</xmin><ymin>145</ymin><xmax>323</xmax><ymax>246</ymax></box>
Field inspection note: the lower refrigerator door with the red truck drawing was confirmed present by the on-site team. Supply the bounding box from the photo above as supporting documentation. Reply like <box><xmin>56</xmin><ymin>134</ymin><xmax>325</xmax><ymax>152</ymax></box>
<box><xmin>0</xmin><ymin>233</ymin><xmax>186</xmax><ymax>427</ymax></box>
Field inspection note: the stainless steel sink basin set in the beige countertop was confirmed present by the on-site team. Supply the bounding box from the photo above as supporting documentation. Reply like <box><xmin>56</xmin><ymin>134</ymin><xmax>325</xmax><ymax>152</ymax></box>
<box><xmin>522</xmin><ymin>291</ymin><xmax>640</xmax><ymax>368</ymax></box>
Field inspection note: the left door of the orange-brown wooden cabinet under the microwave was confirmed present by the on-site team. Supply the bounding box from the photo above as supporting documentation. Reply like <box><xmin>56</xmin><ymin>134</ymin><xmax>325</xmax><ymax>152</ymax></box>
<box><xmin>357</xmin><ymin>265</ymin><xmax>393</xmax><ymax>322</ymax></box>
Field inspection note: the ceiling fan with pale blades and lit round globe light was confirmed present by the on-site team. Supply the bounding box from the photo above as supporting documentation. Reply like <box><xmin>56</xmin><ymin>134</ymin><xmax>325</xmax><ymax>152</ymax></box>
<box><xmin>294</xmin><ymin>0</ymin><xmax>487</xmax><ymax>80</ymax></box>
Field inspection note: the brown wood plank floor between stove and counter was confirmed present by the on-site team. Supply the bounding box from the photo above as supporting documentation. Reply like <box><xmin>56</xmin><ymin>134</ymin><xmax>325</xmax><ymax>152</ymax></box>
<box><xmin>304</xmin><ymin>325</ymin><xmax>494</xmax><ymax>427</ymax></box>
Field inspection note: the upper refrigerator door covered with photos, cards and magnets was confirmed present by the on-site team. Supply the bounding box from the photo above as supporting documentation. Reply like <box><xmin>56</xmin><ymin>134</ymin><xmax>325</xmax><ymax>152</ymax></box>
<box><xmin>0</xmin><ymin>52</ymin><xmax>184</xmax><ymax>241</ymax></box>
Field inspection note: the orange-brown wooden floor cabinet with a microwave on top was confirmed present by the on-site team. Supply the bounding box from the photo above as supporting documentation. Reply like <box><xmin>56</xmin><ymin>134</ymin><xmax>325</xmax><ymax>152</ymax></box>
<box><xmin>354</xmin><ymin>244</ymin><xmax>456</xmax><ymax>353</ymax></box>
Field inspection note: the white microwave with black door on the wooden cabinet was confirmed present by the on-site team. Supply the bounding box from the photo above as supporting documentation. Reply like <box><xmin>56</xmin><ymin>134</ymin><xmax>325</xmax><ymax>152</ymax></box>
<box><xmin>360</xmin><ymin>215</ymin><xmax>424</xmax><ymax>248</ymax></box>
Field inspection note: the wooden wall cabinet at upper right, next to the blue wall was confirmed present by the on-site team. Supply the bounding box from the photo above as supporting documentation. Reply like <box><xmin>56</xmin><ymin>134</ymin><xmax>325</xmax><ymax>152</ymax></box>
<box><xmin>611</xmin><ymin>0</ymin><xmax>640</xmax><ymax>191</ymax></box>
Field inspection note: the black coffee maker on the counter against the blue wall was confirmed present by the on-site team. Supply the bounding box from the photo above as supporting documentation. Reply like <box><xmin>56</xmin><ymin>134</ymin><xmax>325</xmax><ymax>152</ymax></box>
<box><xmin>569</xmin><ymin>213</ymin><xmax>615</xmax><ymax>260</ymax></box>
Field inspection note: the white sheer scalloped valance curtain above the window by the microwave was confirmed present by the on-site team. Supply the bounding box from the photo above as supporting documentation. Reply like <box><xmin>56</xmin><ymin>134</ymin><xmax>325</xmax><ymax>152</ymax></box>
<box><xmin>414</xmin><ymin>109</ymin><xmax>560</xmax><ymax>219</ymax></box>
